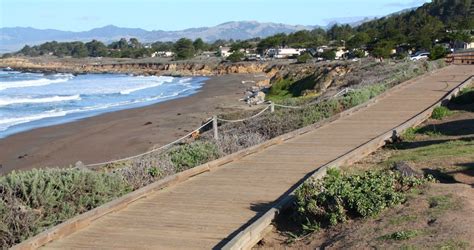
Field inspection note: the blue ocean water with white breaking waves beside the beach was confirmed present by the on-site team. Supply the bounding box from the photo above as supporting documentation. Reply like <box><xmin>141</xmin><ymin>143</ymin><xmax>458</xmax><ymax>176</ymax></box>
<box><xmin>0</xmin><ymin>69</ymin><xmax>207</xmax><ymax>138</ymax></box>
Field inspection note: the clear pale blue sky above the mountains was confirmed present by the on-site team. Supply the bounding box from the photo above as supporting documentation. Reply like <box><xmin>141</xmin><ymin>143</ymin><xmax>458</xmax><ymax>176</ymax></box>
<box><xmin>0</xmin><ymin>0</ymin><xmax>429</xmax><ymax>31</ymax></box>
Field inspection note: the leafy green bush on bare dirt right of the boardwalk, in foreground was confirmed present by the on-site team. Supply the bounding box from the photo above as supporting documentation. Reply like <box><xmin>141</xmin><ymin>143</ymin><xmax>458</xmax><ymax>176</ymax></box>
<box><xmin>295</xmin><ymin>169</ymin><xmax>426</xmax><ymax>227</ymax></box>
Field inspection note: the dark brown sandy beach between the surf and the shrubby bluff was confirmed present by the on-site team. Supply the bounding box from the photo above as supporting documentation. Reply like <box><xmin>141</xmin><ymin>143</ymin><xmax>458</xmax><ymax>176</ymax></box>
<box><xmin>0</xmin><ymin>75</ymin><xmax>255</xmax><ymax>174</ymax></box>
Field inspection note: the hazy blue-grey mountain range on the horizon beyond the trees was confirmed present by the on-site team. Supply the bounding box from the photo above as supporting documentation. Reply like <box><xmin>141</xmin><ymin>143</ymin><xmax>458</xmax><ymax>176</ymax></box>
<box><xmin>0</xmin><ymin>21</ymin><xmax>317</xmax><ymax>53</ymax></box>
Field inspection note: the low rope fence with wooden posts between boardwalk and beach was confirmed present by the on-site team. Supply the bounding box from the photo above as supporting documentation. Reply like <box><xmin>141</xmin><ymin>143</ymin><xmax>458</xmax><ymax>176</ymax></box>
<box><xmin>83</xmin><ymin>88</ymin><xmax>353</xmax><ymax>168</ymax></box>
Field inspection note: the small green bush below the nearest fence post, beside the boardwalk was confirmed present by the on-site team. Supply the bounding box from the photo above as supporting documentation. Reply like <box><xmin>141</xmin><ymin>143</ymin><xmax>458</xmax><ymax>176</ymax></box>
<box><xmin>168</xmin><ymin>141</ymin><xmax>219</xmax><ymax>172</ymax></box>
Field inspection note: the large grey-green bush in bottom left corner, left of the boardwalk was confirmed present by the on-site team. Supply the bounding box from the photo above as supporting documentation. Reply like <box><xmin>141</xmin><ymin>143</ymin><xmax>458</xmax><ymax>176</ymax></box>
<box><xmin>0</xmin><ymin>169</ymin><xmax>130</xmax><ymax>247</ymax></box>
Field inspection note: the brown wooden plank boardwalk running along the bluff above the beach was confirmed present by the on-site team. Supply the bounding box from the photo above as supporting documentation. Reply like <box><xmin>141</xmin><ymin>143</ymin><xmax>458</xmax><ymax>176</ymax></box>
<box><xmin>44</xmin><ymin>65</ymin><xmax>474</xmax><ymax>249</ymax></box>
